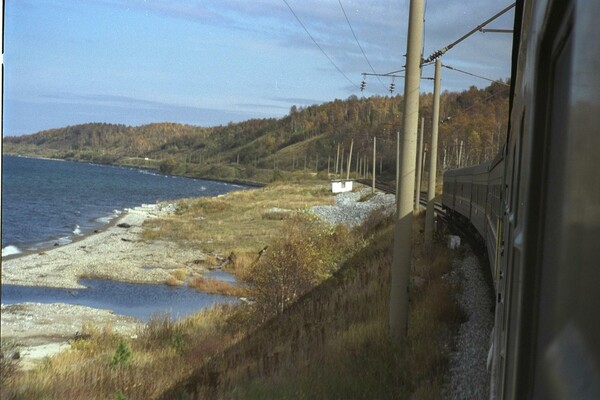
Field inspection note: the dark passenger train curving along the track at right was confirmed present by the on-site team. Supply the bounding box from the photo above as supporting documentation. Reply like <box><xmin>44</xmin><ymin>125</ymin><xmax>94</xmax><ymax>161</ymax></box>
<box><xmin>443</xmin><ymin>0</ymin><xmax>600</xmax><ymax>399</ymax></box>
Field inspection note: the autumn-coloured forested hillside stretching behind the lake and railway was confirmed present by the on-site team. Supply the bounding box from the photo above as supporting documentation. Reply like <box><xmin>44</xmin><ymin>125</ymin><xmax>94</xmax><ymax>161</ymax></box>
<box><xmin>3</xmin><ymin>83</ymin><xmax>509</xmax><ymax>181</ymax></box>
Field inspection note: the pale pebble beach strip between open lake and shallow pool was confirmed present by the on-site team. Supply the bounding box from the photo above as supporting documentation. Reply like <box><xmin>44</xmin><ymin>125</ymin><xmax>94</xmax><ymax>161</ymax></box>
<box><xmin>2</xmin><ymin>205</ymin><xmax>211</xmax><ymax>289</ymax></box>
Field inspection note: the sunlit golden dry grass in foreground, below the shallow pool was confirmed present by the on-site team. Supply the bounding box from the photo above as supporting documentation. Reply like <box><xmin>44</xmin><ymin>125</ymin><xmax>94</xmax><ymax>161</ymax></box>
<box><xmin>0</xmin><ymin>306</ymin><xmax>239</xmax><ymax>399</ymax></box>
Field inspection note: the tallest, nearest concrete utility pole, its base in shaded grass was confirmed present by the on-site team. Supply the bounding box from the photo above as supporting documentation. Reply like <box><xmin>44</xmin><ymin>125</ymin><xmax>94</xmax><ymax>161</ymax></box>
<box><xmin>390</xmin><ymin>0</ymin><xmax>424</xmax><ymax>345</ymax></box>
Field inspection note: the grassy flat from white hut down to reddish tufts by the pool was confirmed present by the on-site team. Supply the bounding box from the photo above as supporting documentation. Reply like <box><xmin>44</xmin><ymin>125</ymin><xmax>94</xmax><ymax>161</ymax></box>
<box><xmin>143</xmin><ymin>180</ymin><xmax>333</xmax><ymax>296</ymax></box>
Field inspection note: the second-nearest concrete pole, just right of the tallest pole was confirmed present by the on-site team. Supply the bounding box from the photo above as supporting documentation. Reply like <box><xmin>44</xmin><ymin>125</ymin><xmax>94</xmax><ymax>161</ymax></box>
<box><xmin>425</xmin><ymin>58</ymin><xmax>442</xmax><ymax>250</ymax></box>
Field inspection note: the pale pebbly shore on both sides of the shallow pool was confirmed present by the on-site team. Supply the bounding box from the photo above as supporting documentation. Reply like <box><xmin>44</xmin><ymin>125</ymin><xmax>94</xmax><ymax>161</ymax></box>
<box><xmin>1</xmin><ymin>204</ymin><xmax>211</xmax><ymax>368</ymax></box>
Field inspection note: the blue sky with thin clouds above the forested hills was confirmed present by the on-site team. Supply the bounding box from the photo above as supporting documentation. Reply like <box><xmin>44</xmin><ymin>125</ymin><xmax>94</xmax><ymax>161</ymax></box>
<box><xmin>2</xmin><ymin>0</ymin><xmax>514</xmax><ymax>136</ymax></box>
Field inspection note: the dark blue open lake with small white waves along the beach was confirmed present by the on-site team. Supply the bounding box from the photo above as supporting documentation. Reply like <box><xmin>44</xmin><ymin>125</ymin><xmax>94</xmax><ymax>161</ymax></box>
<box><xmin>2</xmin><ymin>156</ymin><xmax>242</xmax><ymax>256</ymax></box>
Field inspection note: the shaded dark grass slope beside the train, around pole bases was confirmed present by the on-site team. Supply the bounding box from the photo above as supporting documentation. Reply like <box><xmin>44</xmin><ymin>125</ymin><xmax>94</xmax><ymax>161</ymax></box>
<box><xmin>221</xmin><ymin>212</ymin><xmax>464</xmax><ymax>400</ymax></box>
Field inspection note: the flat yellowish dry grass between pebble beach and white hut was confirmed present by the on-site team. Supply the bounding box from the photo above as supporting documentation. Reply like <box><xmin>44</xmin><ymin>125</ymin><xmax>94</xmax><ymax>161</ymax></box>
<box><xmin>143</xmin><ymin>181</ymin><xmax>333</xmax><ymax>254</ymax></box>
